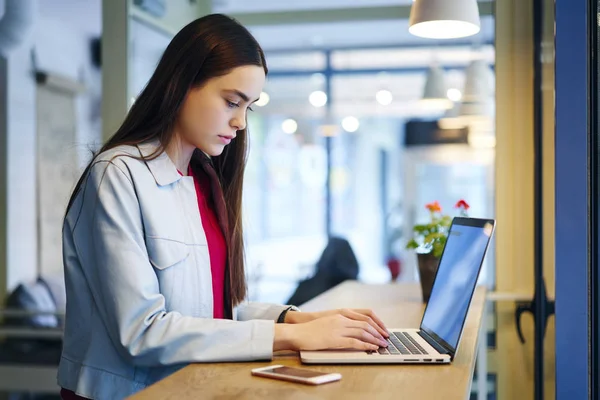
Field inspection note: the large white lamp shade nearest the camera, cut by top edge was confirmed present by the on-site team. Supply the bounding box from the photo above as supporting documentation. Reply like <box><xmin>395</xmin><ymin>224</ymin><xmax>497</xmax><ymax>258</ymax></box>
<box><xmin>408</xmin><ymin>0</ymin><xmax>481</xmax><ymax>39</ymax></box>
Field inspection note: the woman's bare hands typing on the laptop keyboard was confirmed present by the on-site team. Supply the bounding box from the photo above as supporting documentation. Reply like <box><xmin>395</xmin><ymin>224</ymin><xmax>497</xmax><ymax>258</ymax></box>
<box><xmin>273</xmin><ymin>313</ymin><xmax>387</xmax><ymax>351</ymax></box>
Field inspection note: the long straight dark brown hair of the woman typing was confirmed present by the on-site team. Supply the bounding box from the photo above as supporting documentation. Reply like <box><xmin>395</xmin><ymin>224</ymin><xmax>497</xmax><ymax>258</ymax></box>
<box><xmin>67</xmin><ymin>14</ymin><xmax>268</xmax><ymax>306</ymax></box>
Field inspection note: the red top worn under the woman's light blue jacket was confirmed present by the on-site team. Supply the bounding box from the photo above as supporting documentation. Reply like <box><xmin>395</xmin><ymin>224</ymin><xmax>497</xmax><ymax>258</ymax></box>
<box><xmin>188</xmin><ymin>168</ymin><xmax>227</xmax><ymax>319</ymax></box>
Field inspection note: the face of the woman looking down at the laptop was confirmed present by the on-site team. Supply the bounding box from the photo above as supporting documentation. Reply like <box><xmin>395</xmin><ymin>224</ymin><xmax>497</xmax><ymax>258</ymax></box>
<box><xmin>177</xmin><ymin>65</ymin><xmax>265</xmax><ymax>156</ymax></box>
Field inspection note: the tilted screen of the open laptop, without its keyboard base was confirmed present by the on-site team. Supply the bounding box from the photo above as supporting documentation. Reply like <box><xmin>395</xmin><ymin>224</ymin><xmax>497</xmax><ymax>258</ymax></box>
<box><xmin>421</xmin><ymin>218</ymin><xmax>493</xmax><ymax>350</ymax></box>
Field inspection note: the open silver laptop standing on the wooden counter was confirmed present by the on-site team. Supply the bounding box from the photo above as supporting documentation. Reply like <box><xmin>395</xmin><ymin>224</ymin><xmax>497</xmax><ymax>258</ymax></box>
<box><xmin>300</xmin><ymin>217</ymin><xmax>496</xmax><ymax>364</ymax></box>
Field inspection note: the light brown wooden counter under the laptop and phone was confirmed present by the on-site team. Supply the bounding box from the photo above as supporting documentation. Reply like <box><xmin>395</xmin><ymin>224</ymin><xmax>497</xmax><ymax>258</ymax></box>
<box><xmin>132</xmin><ymin>281</ymin><xmax>485</xmax><ymax>400</ymax></box>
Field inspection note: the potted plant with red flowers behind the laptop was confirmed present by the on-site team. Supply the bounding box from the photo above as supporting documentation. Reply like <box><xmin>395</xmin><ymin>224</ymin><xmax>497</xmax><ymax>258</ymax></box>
<box><xmin>406</xmin><ymin>200</ymin><xmax>470</xmax><ymax>303</ymax></box>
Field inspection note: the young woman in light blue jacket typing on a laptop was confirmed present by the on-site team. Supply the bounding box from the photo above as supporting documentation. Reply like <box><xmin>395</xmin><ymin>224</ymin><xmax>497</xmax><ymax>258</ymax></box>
<box><xmin>58</xmin><ymin>15</ymin><xmax>388</xmax><ymax>400</ymax></box>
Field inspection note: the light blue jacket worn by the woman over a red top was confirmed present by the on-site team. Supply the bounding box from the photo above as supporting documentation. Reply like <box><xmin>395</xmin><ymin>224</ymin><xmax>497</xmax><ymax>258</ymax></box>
<box><xmin>58</xmin><ymin>143</ymin><xmax>292</xmax><ymax>400</ymax></box>
